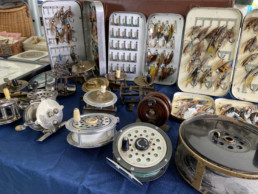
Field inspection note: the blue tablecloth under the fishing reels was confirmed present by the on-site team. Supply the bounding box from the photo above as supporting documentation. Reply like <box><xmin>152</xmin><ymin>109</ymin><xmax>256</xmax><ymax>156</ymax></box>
<box><xmin>0</xmin><ymin>85</ymin><xmax>214</xmax><ymax>194</ymax></box>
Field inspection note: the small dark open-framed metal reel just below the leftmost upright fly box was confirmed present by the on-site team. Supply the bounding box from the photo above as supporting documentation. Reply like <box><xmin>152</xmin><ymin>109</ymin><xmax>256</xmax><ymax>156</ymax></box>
<box><xmin>46</xmin><ymin>68</ymin><xmax>76</xmax><ymax>96</ymax></box>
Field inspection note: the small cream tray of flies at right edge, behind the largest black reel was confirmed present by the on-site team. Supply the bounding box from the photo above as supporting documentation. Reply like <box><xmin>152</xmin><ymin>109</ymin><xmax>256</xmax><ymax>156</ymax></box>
<box><xmin>215</xmin><ymin>98</ymin><xmax>258</xmax><ymax>127</ymax></box>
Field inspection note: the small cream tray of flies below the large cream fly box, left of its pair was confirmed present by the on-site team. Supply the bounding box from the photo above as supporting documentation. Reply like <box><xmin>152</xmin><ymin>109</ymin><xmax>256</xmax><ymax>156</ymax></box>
<box><xmin>171</xmin><ymin>92</ymin><xmax>215</xmax><ymax>120</ymax></box>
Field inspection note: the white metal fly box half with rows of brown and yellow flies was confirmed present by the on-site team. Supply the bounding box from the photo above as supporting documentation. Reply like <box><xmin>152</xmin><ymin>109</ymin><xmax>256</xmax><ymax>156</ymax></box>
<box><xmin>144</xmin><ymin>14</ymin><xmax>184</xmax><ymax>85</ymax></box>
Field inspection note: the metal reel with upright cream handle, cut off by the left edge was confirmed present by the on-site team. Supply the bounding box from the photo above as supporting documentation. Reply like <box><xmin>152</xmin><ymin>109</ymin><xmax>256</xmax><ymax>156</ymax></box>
<box><xmin>0</xmin><ymin>88</ymin><xmax>21</xmax><ymax>125</ymax></box>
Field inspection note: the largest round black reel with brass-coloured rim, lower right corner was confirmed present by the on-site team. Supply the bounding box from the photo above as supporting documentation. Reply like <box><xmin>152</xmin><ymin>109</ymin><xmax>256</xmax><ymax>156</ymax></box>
<box><xmin>175</xmin><ymin>115</ymin><xmax>258</xmax><ymax>193</ymax></box>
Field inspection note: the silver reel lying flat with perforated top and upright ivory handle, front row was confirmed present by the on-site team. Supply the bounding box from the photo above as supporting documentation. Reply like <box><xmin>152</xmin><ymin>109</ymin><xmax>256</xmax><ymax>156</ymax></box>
<box><xmin>65</xmin><ymin>109</ymin><xmax>119</xmax><ymax>148</ymax></box>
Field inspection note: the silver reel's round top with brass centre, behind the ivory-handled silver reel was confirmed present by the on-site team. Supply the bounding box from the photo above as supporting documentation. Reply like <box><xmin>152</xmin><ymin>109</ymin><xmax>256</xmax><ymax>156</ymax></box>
<box><xmin>83</xmin><ymin>90</ymin><xmax>117</xmax><ymax>108</ymax></box>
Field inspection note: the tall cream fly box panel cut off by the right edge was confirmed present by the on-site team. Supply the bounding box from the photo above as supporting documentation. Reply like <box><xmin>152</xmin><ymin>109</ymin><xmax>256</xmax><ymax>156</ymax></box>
<box><xmin>232</xmin><ymin>10</ymin><xmax>258</xmax><ymax>103</ymax></box>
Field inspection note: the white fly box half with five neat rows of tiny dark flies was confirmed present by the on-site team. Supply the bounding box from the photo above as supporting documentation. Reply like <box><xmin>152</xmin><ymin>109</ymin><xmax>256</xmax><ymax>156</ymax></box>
<box><xmin>108</xmin><ymin>12</ymin><xmax>146</xmax><ymax>81</ymax></box>
